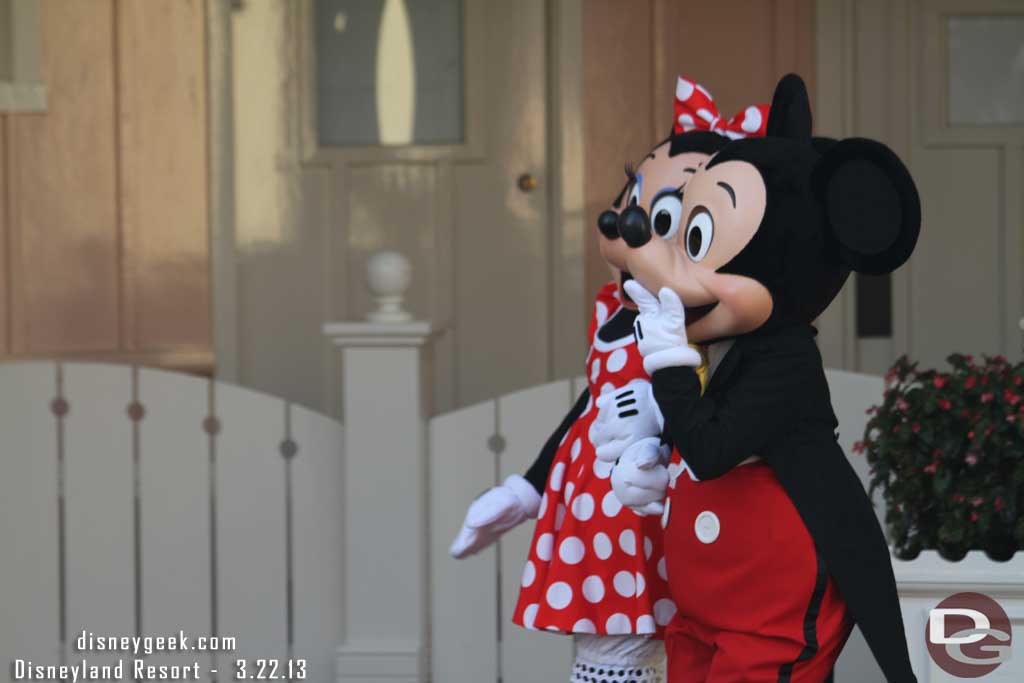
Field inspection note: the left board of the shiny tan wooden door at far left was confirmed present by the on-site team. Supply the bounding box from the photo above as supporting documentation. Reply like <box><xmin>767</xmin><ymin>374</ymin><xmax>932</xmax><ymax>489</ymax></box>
<box><xmin>8</xmin><ymin>0</ymin><xmax>119</xmax><ymax>352</ymax></box>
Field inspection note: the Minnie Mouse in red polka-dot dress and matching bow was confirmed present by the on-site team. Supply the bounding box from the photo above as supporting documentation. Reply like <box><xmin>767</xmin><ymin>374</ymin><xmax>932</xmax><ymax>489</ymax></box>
<box><xmin>452</xmin><ymin>79</ymin><xmax>767</xmax><ymax>683</ymax></box>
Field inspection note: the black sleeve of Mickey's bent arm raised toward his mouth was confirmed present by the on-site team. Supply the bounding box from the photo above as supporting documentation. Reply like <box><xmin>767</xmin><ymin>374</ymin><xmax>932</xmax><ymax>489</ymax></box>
<box><xmin>652</xmin><ymin>341</ymin><xmax>813</xmax><ymax>479</ymax></box>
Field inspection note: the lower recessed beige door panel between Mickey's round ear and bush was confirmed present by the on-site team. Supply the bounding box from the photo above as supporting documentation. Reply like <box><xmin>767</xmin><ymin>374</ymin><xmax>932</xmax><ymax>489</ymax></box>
<box><xmin>907</xmin><ymin>150</ymin><xmax>1002</xmax><ymax>368</ymax></box>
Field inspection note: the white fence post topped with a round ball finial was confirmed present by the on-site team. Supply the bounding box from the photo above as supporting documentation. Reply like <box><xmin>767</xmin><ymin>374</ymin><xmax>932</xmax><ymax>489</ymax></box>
<box><xmin>324</xmin><ymin>252</ymin><xmax>432</xmax><ymax>683</ymax></box>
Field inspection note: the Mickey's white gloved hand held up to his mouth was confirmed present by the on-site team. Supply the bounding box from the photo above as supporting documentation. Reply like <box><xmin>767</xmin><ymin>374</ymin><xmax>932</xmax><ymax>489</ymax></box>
<box><xmin>624</xmin><ymin>280</ymin><xmax>700</xmax><ymax>375</ymax></box>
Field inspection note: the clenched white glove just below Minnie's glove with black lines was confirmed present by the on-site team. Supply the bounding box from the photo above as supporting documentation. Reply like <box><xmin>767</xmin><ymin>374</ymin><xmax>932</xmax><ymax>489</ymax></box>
<box><xmin>611</xmin><ymin>438</ymin><xmax>671</xmax><ymax>515</ymax></box>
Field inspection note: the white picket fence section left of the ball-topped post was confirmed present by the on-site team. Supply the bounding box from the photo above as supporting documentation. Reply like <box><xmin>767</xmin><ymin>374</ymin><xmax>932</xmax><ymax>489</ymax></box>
<box><xmin>0</xmin><ymin>362</ymin><xmax>342</xmax><ymax>682</ymax></box>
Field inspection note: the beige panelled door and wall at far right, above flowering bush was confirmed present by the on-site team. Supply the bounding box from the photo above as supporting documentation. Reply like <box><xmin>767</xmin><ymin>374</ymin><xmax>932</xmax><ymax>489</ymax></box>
<box><xmin>817</xmin><ymin>0</ymin><xmax>1024</xmax><ymax>373</ymax></box>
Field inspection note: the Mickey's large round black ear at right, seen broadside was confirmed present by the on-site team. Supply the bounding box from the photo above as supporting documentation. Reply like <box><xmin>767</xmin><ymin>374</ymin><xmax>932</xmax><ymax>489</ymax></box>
<box><xmin>811</xmin><ymin>137</ymin><xmax>921</xmax><ymax>274</ymax></box>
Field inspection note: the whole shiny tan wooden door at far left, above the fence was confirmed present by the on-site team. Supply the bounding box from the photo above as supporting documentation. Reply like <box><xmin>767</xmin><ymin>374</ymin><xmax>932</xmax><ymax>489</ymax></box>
<box><xmin>0</xmin><ymin>0</ymin><xmax>213</xmax><ymax>372</ymax></box>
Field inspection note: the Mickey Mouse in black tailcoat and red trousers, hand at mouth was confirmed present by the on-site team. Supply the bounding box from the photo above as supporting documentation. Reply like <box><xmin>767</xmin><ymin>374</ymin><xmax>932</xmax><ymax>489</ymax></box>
<box><xmin>616</xmin><ymin>75</ymin><xmax>921</xmax><ymax>683</ymax></box>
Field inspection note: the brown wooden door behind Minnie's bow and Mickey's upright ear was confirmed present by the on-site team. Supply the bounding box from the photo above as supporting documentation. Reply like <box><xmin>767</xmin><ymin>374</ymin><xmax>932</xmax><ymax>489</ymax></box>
<box><xmin>584</xmin><ymin>0</ymin><xmax>815</xmax><ymax>305</ymax></box>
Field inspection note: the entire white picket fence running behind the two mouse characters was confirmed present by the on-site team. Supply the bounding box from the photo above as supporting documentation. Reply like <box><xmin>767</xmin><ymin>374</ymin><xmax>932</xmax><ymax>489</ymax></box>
<box><xmin>0</xmin><ymin>352</ymin><xmax>881</xmax><ymax>683</ymax></box>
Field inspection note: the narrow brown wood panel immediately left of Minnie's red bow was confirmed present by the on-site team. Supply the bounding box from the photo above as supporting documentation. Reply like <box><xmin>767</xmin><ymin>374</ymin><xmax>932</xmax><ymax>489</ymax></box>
<box><xmin>581</xmin><ymin>0</ymin><xmax>651</xmax><ymax>305</ymax></box>
